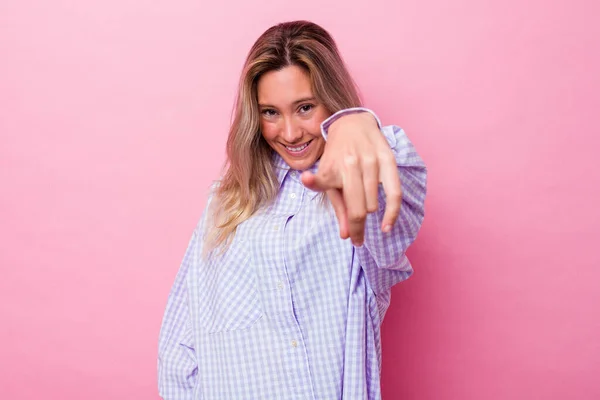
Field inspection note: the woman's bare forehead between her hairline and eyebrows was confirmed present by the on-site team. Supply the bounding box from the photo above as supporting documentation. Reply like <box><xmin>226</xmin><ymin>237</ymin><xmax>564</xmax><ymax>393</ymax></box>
<box><xmin>257</xmin><ymin>65</ymin><xmax>313</xmax><ymax>106</ymax></box>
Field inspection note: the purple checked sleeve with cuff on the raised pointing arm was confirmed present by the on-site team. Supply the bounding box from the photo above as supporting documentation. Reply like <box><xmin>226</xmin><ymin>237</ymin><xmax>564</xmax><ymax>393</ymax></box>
<box><xmin>321</xmin><ymin>108</ymin><xmax>427</xmax><ymax>298</ymax></box>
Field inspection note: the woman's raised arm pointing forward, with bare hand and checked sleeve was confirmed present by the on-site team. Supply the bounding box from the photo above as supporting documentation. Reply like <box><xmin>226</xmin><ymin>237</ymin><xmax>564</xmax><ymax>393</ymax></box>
<box><xmin>305</xmin><ymin>108</ymin><xmax>426</xmax><ymax>294</ymax></box>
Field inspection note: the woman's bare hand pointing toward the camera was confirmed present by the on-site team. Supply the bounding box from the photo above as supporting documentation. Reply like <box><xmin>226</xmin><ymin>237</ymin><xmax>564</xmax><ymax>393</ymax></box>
<box><xmin>302</xmin><ymin>112</ymin><xmax>402</xmax><ymax>246</ymax></box>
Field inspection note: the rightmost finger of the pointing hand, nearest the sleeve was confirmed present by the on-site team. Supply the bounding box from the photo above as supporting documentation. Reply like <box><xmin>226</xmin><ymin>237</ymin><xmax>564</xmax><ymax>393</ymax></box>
<box><xmin>379</xmin><ymin>148</ymin><xmax>402</xmax><ymax>232</ymax></box>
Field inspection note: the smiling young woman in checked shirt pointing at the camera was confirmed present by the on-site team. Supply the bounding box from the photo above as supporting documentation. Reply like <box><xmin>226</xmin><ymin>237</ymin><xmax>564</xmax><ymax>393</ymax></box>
<box><xmin>158</xmin><ymin>21</ymin><xmax>426</xmax><ymax>400</ymax></box>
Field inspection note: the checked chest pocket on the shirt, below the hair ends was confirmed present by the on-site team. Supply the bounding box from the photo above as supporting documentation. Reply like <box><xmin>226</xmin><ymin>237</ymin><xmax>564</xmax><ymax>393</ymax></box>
<box><xmin>194</xmin><ymin>224</ymin><xmax>263</xmax><ymax>334</ymax></box>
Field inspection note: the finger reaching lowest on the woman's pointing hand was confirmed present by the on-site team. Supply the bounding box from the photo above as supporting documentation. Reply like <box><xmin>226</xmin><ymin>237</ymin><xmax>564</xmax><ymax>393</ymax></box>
<box><xmin>342</xmin><ymin>156</ymin><xmax>367</xmax><ymax>246</ymax></box>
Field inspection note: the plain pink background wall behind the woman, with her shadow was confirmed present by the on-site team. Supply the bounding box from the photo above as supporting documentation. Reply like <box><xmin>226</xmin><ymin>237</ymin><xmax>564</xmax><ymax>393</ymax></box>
<box><xmin>0</xmin><ymin>0</ymin><xmax>600</xmax><ymax>400</ymax></box>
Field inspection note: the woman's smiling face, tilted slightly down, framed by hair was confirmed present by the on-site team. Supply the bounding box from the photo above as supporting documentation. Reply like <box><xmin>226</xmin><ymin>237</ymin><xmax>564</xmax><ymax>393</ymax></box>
<box><xmin>257</xmin><ymin>65</ymin><xmax>329</xmax><ymax>171</ymax></box>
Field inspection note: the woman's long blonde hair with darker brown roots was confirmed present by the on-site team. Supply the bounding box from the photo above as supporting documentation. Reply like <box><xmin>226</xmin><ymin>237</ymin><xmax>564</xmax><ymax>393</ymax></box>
<box><xmin>204</xmin><ymin>21</ymin><xmax>361</xmax><ymax>254</ymax></box>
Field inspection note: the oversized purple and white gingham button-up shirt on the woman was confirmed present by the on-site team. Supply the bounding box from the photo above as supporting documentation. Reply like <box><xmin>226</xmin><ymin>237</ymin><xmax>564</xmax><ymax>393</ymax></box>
<box><xmin>158</xmin><ymin>109</ymin><xmax>426</xmax><ymax>400</ymax></box>
